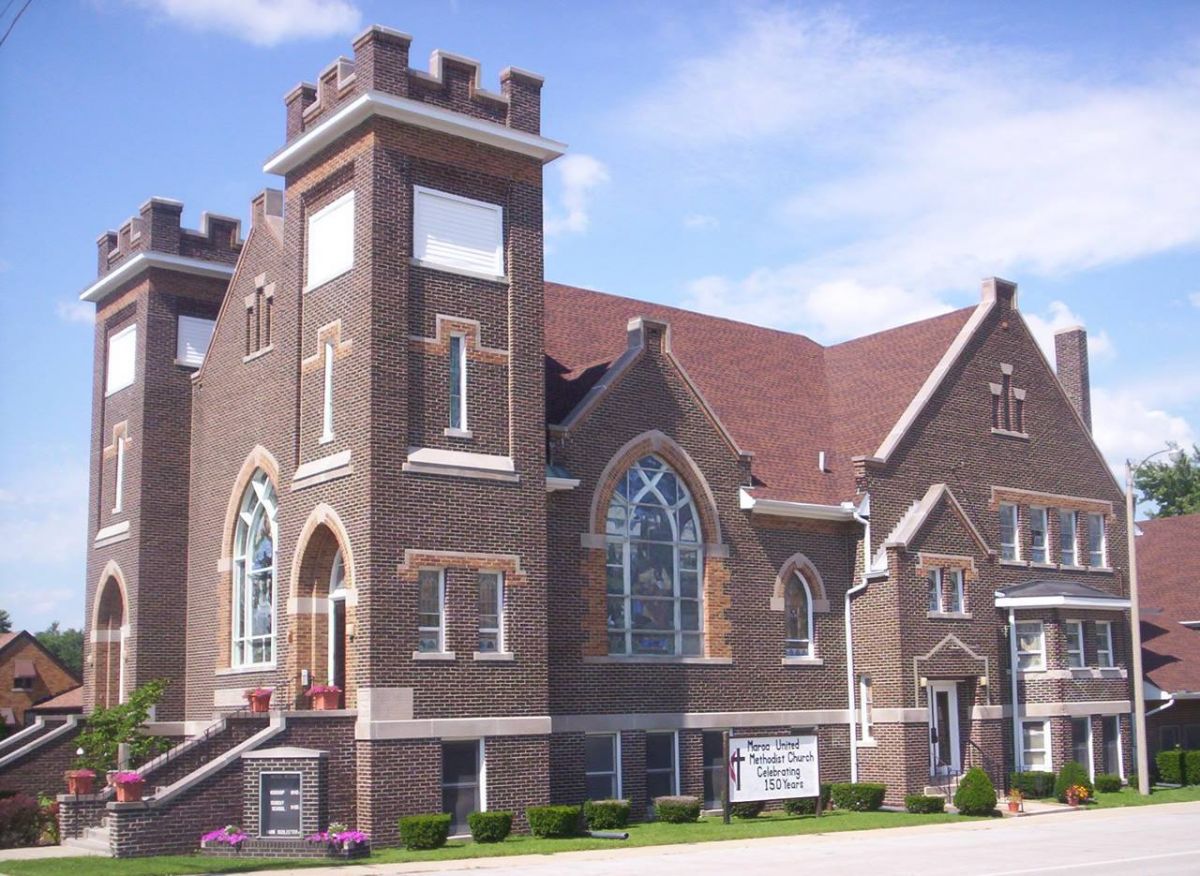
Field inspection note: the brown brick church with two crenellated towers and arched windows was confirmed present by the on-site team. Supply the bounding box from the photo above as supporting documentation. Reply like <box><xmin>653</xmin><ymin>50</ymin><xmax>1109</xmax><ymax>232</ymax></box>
<box><xmin>0</xmin><ymin>26</ymin><xmax>1132</xmax><ymax>854</ymax></box>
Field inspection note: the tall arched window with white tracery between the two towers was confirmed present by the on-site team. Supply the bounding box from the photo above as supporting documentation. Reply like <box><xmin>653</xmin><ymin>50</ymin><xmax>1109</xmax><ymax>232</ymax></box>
<box><xmin>233</xmin><ymin>469</ymin><xmax>277</xmax><ymax>666</ymax></box>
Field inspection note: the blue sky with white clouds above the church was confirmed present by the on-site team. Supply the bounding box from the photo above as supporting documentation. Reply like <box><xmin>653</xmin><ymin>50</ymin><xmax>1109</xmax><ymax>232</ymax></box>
<box><xmin>0</xmin><ymin>0</ymin><xmax>1200</xmax><ymax>629</ymax></box>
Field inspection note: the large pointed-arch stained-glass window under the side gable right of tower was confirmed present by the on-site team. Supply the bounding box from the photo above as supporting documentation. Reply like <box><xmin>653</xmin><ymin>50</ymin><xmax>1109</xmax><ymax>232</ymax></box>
<box><xmin>606</xmin><ymin>456</ymin><xmax>703</xmax><ymax>656</ymax></box>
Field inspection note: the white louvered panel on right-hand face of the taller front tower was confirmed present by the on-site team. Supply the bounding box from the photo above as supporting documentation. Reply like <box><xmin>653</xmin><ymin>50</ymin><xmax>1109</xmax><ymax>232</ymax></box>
<box><xmin>413</xmin><ymin>186</ymin><xmax>504</xmax><ymax>277</ymax></box>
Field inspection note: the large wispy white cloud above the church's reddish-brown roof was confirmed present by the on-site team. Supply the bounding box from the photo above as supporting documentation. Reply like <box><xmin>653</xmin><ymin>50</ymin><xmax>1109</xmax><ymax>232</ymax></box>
<box><xmin>628</xmin><ymin>10</ymin><xmax>1200</xmax><ymax>340</ymax></box>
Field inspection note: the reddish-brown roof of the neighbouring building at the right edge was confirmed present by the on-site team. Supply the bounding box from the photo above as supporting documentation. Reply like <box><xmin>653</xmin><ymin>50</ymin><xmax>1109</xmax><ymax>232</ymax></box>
<box><xmin>1138</xmin><ymin>514</ymin><xmax>1200</xmax><ymax>692</ymax></box>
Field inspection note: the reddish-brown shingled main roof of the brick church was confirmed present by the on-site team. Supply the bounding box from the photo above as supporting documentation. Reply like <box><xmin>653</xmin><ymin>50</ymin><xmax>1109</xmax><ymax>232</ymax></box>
<box><xmin>546</xmin><ymin>283</ymin><xmax>974</xmax><ymax>504</ymax></box>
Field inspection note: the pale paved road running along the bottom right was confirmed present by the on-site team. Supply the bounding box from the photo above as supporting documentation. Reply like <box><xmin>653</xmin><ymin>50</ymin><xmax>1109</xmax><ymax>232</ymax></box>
<box><xmin>274</xmin><ymin>803</ymin><xmax>1200</xmax><ymax>876</ymax></box>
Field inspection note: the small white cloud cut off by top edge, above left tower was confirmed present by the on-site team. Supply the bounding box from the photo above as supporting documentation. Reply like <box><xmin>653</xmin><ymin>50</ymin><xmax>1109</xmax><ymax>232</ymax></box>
<box><xmin>128</xmin><ymin>0</ymin><xmax>362</xmax><ymax>46</ymax></box>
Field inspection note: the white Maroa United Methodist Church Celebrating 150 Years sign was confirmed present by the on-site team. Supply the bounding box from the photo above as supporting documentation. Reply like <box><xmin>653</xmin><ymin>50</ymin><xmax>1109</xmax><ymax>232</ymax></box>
<box><xmin>728</xmin><ymin>736</ymin><xmax>821</xmax><ymax>803</ymax></box>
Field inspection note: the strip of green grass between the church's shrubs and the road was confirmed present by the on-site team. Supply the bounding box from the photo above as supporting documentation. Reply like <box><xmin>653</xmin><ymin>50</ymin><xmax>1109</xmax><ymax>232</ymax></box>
<box><xmin>0</xmin><ymin>812</ymin><xmax>968</xmax><ymax>876</ymax></box>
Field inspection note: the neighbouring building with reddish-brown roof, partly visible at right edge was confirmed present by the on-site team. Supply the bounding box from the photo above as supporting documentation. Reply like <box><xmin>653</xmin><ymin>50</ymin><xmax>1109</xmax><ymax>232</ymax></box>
<box><xmin>1138</xmin><ymin>514</ymin><xmax>1200</xmax><ymax>752</ymax></box>
